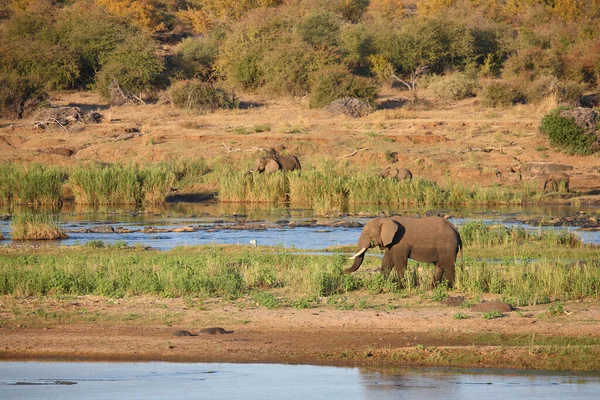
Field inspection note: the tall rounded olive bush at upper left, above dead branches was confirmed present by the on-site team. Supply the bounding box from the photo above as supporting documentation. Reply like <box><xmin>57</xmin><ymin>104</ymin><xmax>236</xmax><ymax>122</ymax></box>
<box><xmin>96</xmin><ymin>36</ymin><xmax>163</xmax><ymax>98</ymax></box>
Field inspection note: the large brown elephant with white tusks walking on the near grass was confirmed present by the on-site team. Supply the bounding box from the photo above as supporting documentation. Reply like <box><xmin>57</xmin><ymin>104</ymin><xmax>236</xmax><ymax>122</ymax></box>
<box><xmin>344</xmin><ymin>216</ymin><xmax>462</xmax><ymax>287</ymax></box>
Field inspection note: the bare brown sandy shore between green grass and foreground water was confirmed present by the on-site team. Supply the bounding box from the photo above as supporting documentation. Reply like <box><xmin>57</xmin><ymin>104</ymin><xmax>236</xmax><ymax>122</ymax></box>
<box><xmin>0</xmin><ymin>298</ymin><xmax>600</xmax><ymax>372</ymax></box>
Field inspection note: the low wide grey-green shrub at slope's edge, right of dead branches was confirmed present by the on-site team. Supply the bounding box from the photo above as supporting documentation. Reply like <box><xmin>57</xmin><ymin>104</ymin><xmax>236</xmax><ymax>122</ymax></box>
<box><xmin>168</xmin><ymin>79</ymin><xmax>239</xmax><ymax>111</ymax></box>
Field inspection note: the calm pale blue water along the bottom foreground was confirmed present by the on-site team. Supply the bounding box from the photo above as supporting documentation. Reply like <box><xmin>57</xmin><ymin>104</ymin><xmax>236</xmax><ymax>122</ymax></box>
<box><xmin>0</xmin><ymin>362</ymin><xmax>600</xmax><ymax>400</ymax></box>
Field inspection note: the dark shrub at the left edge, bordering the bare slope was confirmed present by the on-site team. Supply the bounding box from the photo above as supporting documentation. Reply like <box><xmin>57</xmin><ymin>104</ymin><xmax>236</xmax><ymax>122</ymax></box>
<box><xmin>0</xmin><ymin>74</ymin><xmax>48</xmax><ymax>119</ymax></box>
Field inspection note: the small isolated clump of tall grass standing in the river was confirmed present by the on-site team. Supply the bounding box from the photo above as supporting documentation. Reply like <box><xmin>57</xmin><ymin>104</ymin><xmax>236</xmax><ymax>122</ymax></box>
<box><xmin>10</xmin><ymin>212</ymin><xmax>68</xmax><ymax>240</ymax></box>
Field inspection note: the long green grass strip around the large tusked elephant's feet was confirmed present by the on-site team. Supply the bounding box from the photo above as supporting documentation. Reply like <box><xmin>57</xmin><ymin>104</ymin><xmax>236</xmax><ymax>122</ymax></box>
<box><xmin>0</xmin><ymin>239</ymin><xmax>600</xmax><ymax>306</ymax></box>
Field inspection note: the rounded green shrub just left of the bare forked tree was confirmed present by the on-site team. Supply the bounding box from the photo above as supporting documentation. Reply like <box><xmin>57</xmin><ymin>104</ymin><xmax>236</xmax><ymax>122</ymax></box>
<box><xmin>308</xmin><ymin>67</ymin><xmax>377</xmax><ymax>108</ymax></box>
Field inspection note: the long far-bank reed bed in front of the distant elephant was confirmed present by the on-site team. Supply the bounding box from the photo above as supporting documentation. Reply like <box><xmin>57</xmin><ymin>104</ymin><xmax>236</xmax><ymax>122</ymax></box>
<box><xmin>219</xmin><ymin>162</ymin><xmax>541</xmax><ymax>214</ymax></box>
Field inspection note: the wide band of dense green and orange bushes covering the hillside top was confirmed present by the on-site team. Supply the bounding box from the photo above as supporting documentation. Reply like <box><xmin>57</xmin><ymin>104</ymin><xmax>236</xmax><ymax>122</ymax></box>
<box><xmin>0</xmin><ymin>0</ymin><xmax>600</xmax><ymax>107</ymax></box>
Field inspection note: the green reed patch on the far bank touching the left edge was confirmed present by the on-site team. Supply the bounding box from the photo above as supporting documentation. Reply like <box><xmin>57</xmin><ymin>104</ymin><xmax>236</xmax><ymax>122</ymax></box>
<box><xmin>0</xmin><ymin>163</ymin><xmax>64</xmax><ymax>205</ymax></box>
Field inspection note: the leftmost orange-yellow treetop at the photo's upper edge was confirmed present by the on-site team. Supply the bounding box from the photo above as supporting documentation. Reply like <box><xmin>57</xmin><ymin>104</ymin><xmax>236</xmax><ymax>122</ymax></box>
<box><xmin>95</xmin><ymin>0</ymin><xmax>165</xmax><ymax>32</ymax></box>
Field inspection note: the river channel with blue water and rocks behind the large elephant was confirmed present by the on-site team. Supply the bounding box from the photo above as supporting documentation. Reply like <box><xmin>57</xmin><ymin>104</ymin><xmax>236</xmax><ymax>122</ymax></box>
<box><xmin>0</xmin><ymin>203</ymin><xmax>600</xmax><ymax>250</ymax></box>
